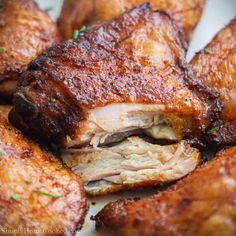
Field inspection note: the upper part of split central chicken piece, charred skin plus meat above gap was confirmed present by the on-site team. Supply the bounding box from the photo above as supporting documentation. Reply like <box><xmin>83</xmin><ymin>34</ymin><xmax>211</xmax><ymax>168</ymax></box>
<box><xmin>10</xmin><ymin>4</ymin><xmax>221</xmax><ymax>148</ymax></box>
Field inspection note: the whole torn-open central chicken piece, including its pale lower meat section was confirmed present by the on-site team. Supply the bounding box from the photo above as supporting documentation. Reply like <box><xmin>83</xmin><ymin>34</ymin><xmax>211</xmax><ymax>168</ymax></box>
<box><xmin>10</xmin><ymin>4</ymin><xmax>220</xmax><ymax>194</ymax></box>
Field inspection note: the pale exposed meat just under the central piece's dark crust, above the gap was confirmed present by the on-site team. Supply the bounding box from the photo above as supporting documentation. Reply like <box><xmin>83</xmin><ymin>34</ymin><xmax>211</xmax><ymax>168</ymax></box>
<box><xmin>67</xmin><ymin>103</ymin><xmax>181</xmax><ymax>147</ymax></box>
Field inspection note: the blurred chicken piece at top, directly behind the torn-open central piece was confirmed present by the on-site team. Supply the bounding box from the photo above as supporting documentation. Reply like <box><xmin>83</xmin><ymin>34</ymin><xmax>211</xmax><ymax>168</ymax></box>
<box><xmin>58</xmin><ymin>0</ymin><xmax>205</xmax><ymax>40</ymax></box>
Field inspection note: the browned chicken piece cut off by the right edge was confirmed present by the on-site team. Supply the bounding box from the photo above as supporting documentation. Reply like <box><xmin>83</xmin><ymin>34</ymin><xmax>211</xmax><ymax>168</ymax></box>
<box><xmin>191</xmin><ymin>19</ymin><xmax>236</xmax><ymax>146</ymax></box>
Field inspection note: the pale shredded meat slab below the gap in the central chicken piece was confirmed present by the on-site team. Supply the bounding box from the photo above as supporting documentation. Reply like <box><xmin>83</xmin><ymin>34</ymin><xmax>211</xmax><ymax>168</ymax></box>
<box><xmin>63</xmin><ymin>137</ymin><xmax>200</xmax><ymax>195</ymax></box>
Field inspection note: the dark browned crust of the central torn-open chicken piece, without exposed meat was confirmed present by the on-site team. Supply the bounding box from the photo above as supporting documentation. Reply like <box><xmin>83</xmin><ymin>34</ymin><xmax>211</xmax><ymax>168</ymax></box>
<box><xmin>11</xmin><ymin>4</ymin><xmax>221</xmax><ymax>146</ymax></box>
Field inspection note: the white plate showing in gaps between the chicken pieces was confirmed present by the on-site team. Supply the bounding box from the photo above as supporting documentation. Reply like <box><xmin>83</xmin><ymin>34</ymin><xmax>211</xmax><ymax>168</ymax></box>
<box><xmin>37</xmin><ymin>0</ymin><xmax>236</xmax><ymax>236</ymax></box>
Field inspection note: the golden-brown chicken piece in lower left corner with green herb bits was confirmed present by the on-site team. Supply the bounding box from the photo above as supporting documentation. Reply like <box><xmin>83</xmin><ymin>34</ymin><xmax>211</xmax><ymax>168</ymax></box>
<box><xmin>0</xmin><ymin>107</ymin><xmax>87</xmax><ymax>235</ymax></box>
